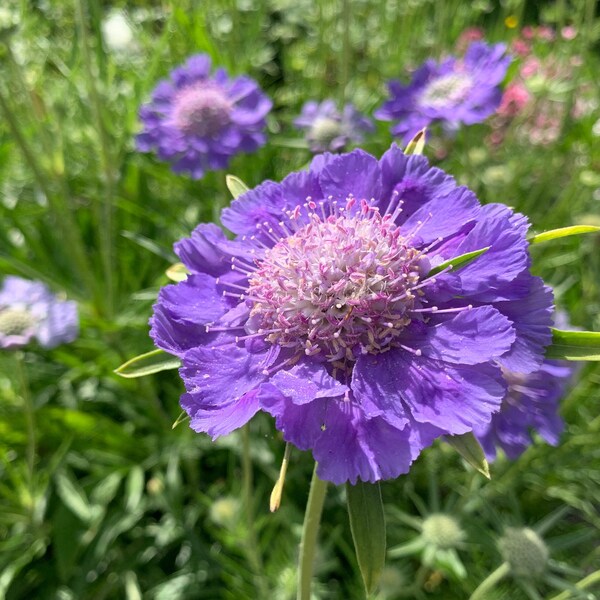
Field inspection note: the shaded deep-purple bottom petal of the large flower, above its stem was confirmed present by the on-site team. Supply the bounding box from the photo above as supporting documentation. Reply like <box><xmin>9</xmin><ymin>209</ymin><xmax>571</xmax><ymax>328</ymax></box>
<box><xmin>313</xmin><ymin>400</ymin><xmax>412</xmax><ymax>485</ymax></box>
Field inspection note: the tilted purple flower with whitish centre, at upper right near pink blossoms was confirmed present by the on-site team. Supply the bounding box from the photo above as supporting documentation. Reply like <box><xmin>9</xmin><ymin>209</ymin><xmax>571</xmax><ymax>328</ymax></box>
<box><xmin>375</xmin><ymin>42</ymin><xmax>511</xmax><ymax>143</ymax></box>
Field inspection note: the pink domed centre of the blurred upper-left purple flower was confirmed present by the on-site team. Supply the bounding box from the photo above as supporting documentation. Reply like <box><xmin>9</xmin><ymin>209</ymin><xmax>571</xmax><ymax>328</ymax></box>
<box><xmin>174</xmin><ymin>82</ymin><xmax>231</xmax><ymax>137</ymax></box>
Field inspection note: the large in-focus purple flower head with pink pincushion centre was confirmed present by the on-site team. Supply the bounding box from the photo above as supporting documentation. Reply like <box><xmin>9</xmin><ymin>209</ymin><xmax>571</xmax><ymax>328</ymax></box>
<box><xmin>151</xmin><ymin>146</ymin><xmax>553</xmax><ymax>483</ymax></box>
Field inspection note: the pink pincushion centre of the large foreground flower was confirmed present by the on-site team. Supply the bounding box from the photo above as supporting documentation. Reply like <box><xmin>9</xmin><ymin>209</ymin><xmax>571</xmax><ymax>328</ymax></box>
<box><xmin>248</xmin><ymin>198</ymin><xmax>424</xmax><ymax>361</ymax></box>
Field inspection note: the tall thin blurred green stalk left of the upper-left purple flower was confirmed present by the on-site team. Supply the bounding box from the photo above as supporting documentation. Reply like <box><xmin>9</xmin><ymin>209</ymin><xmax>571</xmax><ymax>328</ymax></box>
<box><xmin>75</xmin><ymin>0</ymin><xmax>116</xmax><ymax>317</ymax></box>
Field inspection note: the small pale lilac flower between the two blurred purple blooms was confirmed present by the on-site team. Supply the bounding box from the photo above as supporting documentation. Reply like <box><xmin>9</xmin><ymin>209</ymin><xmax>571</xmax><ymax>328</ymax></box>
<box><xmin>294</xmin><ymin>100</ymin><xmax>374</xmax><ymax>153</ymax></box>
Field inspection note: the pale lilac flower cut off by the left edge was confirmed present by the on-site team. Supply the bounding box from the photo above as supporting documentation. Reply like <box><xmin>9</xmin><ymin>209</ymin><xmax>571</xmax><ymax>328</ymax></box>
<box><xmin>0</xmin><ymin>276</ymin><xmax>79</xmax><ymax>349</ymax></box>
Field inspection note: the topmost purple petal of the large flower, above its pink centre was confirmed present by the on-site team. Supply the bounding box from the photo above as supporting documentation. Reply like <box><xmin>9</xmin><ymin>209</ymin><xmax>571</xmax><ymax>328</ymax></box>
<box><xmin>319</xmin><ymin>150</ymin><xmax>381</xmax><ymax>202</ymax></box>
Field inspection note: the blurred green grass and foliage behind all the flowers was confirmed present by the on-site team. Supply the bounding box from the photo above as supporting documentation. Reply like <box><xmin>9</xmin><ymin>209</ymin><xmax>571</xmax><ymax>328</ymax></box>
<box><xmin>0</xmin><ymin>0</ymin><xmax>600</xmax><ymax>600</ymax></box>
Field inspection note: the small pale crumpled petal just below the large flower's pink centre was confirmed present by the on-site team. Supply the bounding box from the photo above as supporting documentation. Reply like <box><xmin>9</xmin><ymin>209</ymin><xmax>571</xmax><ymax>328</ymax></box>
<box><xmin>271</xmin><ymin>360</ymin><xmax>348</xmax><ymax>404</ymax></box>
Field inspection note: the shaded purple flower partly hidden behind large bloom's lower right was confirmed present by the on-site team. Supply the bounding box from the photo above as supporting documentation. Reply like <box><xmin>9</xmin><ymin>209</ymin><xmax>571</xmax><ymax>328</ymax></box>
<box><xmin>474</xmin><ymin>360</ymin><xmax>575</xmax><ymax>460</ymax></box>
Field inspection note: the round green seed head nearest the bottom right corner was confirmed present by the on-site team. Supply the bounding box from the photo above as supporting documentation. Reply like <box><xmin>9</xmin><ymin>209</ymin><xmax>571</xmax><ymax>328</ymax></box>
<box><xmin>498</xmin><ymin>527</ymin><xmax>550</xmax><ymax>579</ymax></box>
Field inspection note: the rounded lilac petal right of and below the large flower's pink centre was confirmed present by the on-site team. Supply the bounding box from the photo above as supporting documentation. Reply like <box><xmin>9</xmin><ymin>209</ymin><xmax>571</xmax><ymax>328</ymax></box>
<box><xmin>405</xmin><ymin>306</ymin><xmax>515</xmax><ymax>365</ymax></box>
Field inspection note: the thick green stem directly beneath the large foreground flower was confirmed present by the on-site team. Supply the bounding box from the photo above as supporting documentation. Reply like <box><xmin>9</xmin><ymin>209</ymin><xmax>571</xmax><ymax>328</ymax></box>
<box><xmin>297</xmin><ymin>464</ymin><xmax>327</xmax><ymax>600</ymax></box>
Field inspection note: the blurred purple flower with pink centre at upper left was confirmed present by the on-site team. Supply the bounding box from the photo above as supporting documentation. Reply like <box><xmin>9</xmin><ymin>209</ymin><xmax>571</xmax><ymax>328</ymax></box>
<box><xmin>136</xmin><ymin>54</ymin><xmax>272</xmax><ymax>179</ymax></box>
